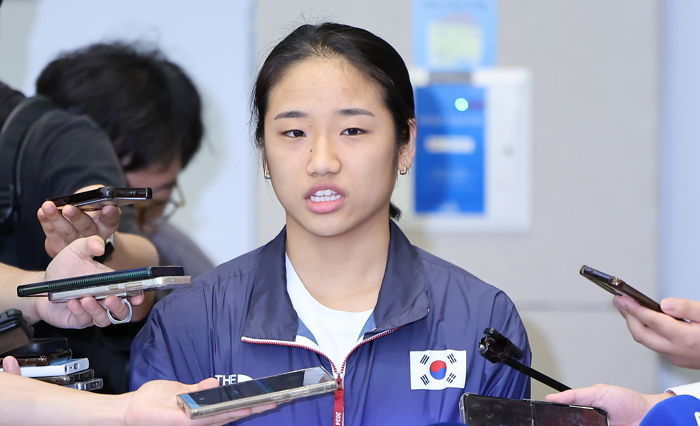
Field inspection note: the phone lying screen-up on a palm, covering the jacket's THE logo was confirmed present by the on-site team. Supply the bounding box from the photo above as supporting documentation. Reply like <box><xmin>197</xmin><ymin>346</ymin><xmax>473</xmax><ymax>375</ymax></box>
<box><xmin>177</xmin><ymin>367</ymin><xmax>338</xmax><ymax>419</ymax></box>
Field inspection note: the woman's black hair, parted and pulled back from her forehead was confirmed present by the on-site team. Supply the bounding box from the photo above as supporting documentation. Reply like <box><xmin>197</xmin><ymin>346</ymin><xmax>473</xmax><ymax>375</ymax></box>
<box><xmin>253</xmin><ymin>22</ymin><xmax>415</xmax><ymax>219</ymax></box>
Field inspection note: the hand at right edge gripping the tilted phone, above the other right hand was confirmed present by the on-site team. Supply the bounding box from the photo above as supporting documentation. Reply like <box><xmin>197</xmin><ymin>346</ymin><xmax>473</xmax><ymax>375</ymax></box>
<box><xmin>613</xmin><ymin>296</ymin><xmax>700</xmax><ymax>369</ymax></box>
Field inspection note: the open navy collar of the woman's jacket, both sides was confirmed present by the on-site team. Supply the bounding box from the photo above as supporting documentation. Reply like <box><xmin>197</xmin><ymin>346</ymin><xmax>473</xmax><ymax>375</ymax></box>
<box><xmin>243</xmin><ymin>221</ymin><xmax>429</xmax><ymax>341</ymax></box>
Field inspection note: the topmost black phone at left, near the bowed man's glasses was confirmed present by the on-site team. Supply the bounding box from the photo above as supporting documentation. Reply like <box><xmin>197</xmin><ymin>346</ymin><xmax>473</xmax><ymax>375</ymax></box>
<box><xmin>49</xmin><ymin>186</ymin><xmax>153</xmax><ymax>211</ymax></box>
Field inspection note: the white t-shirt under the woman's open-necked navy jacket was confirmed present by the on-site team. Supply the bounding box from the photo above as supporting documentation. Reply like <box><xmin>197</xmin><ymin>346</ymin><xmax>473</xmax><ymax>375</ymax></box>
<box><xmin>285</xmin><ymin>255</ymin><xmax>373</xmax><ymax>373</ymax></box>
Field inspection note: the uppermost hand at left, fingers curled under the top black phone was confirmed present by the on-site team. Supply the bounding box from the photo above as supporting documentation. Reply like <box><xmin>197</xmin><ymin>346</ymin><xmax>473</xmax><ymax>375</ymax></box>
<box><xmin>37</xmin><ymin>195</ymin><xmax>121</xmax><ymax>257</ymax></box>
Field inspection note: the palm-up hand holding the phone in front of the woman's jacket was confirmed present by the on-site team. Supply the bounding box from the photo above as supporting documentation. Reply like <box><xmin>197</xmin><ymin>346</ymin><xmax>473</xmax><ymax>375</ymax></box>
<box><xmin>125</xmin><ymin>378</ymin><xmax>276</xmax><ymax>425</ymax></box>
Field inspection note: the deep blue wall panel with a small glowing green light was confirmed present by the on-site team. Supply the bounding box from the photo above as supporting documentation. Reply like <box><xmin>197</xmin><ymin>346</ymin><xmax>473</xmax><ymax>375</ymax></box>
<box><xmin>414</xmin><ymin>84</ymin><xmax>486</xmax><ymax>214</ymax></box>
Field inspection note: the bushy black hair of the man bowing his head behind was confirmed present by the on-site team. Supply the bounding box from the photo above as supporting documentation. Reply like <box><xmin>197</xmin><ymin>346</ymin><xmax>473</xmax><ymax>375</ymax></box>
<box><xmin>36</xmin><ymin>42</ymin><xmax>203</xmax><ymax>172</ymax></box>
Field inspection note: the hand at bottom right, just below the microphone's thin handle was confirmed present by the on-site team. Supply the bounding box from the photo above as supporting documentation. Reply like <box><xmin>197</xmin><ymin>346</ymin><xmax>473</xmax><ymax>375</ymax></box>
<box><xmin>545</xmin><ymin>384</ymin><xmax>673</xmax><ymax>426</ymax></box>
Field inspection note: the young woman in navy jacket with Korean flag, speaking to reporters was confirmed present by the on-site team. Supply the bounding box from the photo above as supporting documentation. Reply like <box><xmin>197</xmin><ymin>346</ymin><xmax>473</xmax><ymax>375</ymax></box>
<box><xmin>131</xmin><ymin>23</ymin><xmax>530</xmax><ymax>425</ymax></box>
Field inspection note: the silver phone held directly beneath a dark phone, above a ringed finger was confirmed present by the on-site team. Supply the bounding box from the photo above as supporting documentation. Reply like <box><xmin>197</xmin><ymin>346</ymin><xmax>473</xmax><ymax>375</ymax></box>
<box><xmin>49</xmin><ymin>275</ymin><xmax>192</xmax><ymax>302</ymax></box>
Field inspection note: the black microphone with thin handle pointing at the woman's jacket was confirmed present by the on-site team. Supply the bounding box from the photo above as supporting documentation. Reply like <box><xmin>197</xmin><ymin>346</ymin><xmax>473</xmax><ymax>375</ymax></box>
<box><xmin>479</xmin><ymin>327</ymin><xmax>571</xmax><ymax>392</ymax></box>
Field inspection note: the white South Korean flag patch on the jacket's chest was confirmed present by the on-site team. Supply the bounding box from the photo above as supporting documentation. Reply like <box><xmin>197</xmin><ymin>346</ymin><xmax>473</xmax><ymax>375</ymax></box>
<box><xmin>410</xmin><ymin>349</ymin><xmax>467</xmax><ymax>390</ymax></box>
